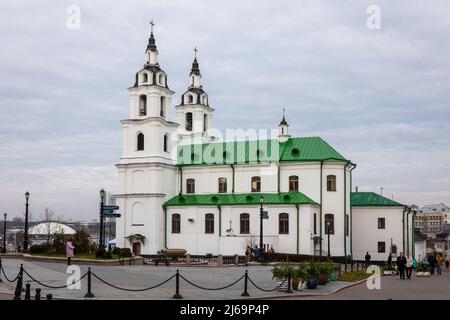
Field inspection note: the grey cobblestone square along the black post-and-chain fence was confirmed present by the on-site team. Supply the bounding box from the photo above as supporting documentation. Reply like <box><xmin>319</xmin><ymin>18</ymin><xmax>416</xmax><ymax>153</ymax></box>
<box><xmin>0</xmin><ymin>259</ymin><xmax>349</xmax><ymax>300</ymax></box>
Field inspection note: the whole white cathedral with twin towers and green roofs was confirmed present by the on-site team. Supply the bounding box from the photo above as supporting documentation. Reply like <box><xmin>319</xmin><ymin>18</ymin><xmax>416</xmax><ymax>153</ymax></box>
<box><xmin>114</xmin><ymin>26</ymin><xmax>412</xmax><ymax>259</ymax></box>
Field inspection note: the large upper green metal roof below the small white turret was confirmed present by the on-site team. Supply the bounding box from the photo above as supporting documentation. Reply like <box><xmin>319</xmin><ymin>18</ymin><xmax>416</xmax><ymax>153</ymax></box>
<box><xmin>178</xmin><ymin>137</ymin><xmax>347</xmax><ymax>166</ymax></box>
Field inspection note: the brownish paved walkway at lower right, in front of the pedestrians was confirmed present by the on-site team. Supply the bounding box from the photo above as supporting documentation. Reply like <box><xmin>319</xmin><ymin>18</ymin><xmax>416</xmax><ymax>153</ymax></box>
<box><xmin>278</xmin><ymin>270</ymin><xmax>450</xmax><ymax>300</ymax></box>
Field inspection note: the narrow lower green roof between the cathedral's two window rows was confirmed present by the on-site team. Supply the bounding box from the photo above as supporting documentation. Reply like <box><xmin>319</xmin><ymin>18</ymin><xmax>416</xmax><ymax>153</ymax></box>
<box><xmin>164</xmin><ymin>192</ymin><xmax>317</xmax><ymax>207</ymax></box>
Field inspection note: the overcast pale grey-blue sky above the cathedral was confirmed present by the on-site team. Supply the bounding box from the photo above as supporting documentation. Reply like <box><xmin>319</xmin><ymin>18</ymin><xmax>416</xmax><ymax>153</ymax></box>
<box><xmin>0</xmin><ymin>0</ymin><xmax>450</xmax><ymax>219</ymax></box>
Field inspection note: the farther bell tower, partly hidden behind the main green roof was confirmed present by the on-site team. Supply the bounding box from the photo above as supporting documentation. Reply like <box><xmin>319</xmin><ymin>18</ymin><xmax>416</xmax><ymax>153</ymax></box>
<box><xmin>175</xmin><ymin>48</ymin><xmax>214</xmax><ymax>144</ymax></box>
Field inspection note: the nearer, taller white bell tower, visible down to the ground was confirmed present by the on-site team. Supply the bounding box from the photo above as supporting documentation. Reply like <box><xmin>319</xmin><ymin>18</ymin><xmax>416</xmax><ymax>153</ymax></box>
<box><xmin>114</xmin><ymin>21</ymin><xmax>178</xmax><ymax>254</ymax></box>
